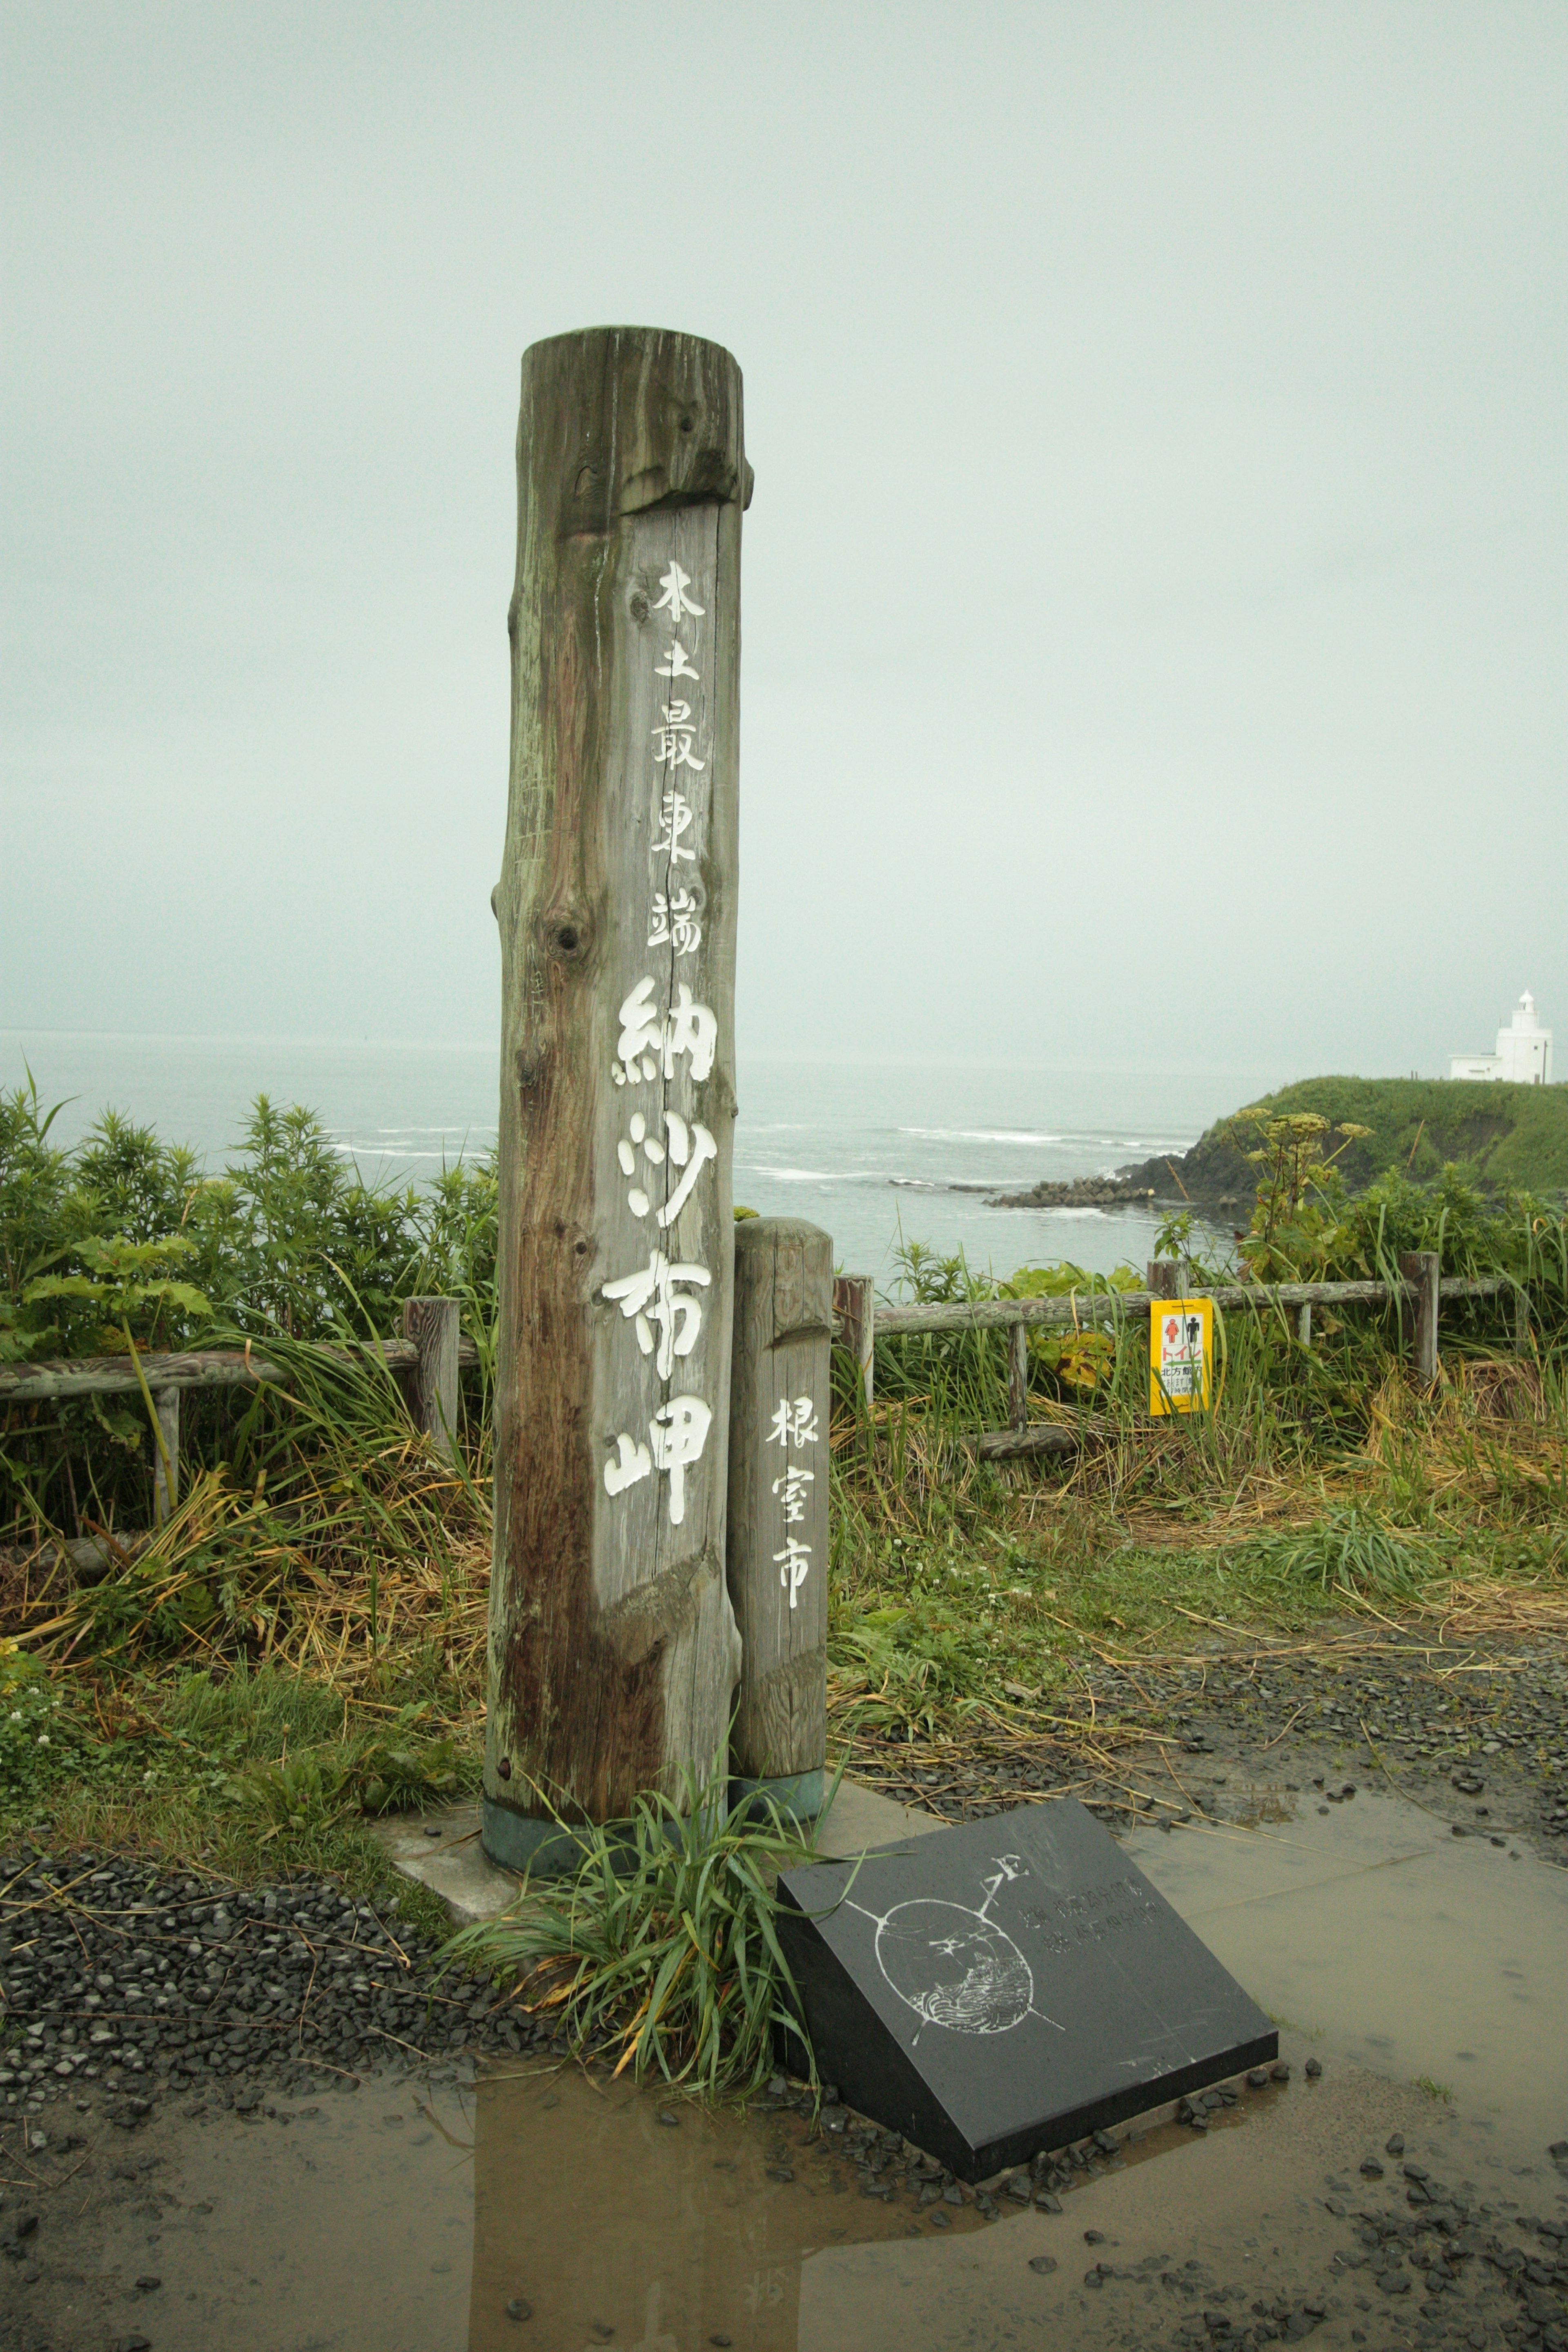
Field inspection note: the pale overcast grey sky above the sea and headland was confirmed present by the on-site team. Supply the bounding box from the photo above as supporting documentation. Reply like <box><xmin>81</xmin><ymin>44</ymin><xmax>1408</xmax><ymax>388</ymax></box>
<box><xmin>0</xmin><ymin>0</ymin><xmax>1568</xmax><ymax>1080</ymax></box>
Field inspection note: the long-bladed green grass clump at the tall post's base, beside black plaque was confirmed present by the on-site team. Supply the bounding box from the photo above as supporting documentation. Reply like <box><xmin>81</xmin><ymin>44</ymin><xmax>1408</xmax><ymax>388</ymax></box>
<box><xmin>447</xmin><ymin>1766</ymin><xmax>816</xmax><ymax>2098</ymax></box>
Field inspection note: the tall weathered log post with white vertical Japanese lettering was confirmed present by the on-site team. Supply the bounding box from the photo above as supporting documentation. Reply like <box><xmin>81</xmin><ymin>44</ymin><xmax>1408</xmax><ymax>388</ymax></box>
<box><xmin>482</xmin><ymin>327</ymin><xmax>750</xmax><ymax>1870</ymax></box>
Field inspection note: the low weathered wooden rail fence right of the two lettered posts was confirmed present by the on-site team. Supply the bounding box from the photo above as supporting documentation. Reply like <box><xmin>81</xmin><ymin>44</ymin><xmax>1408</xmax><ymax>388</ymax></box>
<box><xmin>832</xmin><ymin>1249</ymin><xmax>1530</xmax><ymax>1461</ymax></box>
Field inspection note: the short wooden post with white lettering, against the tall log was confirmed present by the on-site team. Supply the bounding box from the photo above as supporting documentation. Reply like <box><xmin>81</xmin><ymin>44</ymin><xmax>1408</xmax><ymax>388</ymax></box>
<box><xmin>729</xmin><ymin>1216</ymin><xmax>835</xmax><ymax>1820</ymax></box>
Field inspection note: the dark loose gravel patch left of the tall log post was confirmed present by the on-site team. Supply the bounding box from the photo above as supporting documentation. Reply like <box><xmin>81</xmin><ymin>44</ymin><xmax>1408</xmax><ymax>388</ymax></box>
<box><xmin>0</xmin><ymin>1853</ymin><xmax>566</xmax><ymax>2124</ymax></box>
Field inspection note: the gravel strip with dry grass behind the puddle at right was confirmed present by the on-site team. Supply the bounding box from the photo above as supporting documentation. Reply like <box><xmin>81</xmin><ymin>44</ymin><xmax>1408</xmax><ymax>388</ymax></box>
<box><xmin>853</xmin><ymin>1630</ymin><xmax>1568</xmax><ymax>1860</ymax></box>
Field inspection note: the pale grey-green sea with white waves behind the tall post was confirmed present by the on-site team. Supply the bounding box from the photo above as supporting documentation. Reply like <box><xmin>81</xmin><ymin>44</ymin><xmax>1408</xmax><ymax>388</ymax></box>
<box><xmin>0</xmin><ymin>1030</ymin><xmax>1281</xmax><ymax>1282</ymax></box>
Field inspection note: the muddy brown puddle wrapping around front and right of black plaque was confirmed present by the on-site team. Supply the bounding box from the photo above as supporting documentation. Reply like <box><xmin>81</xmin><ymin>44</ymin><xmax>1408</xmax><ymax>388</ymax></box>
<box><xmin>52</xmin><ymin>1797</ymin><xmax>1568</xmax><ymax>2352</ymax></box>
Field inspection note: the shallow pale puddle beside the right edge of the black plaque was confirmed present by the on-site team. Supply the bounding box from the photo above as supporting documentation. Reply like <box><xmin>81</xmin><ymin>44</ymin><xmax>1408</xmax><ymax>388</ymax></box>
<box><xmin>1126</xmin><ymin>1792</ymin><xmax>1568</xmax><ymax>2161</ymax></box>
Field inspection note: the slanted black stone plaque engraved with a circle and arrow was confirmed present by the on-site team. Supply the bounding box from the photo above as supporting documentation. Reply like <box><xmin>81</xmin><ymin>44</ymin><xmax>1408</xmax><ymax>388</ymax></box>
<box><xmin>778</xmin><ymin>1799</ymin><xmax>1279</xmax><ymax>2180</ymax></box>
